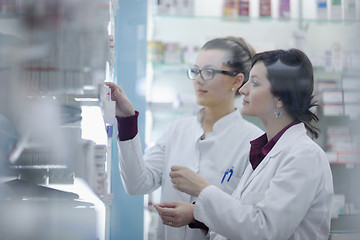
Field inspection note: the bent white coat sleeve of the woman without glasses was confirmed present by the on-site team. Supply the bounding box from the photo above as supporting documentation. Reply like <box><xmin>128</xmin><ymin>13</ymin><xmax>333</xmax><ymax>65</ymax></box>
<box><xmin>194</xmin><ymin>143</ymin><xmax>324</xmax><ymax>240</ymax></box>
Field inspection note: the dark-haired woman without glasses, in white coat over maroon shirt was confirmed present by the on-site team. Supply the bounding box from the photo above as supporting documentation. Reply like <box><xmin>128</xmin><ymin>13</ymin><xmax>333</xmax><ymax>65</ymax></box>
<box><xmin>156</xmin><ymin>49</ymin><xmax>333</xmax><ymax>240</ymax></box>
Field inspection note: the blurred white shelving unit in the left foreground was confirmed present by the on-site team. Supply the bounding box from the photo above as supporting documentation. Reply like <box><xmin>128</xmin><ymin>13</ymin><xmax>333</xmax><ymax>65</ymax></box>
<box><xmin>0</xmin><ymin>0</ymin><xmax>114</xmax><ymax>240</ymax></box>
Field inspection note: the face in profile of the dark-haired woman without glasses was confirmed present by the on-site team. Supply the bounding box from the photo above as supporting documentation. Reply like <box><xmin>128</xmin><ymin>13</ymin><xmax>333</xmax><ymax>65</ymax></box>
<box><xmin>239</xmin><ymin>61</ymin><xmax>276</xmax><ymax>120</ymax></box>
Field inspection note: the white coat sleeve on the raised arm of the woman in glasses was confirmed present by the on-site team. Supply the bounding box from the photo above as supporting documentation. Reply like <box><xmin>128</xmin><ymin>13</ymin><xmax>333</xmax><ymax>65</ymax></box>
<box><xmin>118</xmin><ymin>125</ymin><xmax>167</xmax><ymax>195</ymax></box>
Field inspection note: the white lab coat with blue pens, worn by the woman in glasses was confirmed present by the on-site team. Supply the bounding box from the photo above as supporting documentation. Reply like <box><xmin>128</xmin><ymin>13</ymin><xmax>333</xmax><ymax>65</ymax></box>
<box><xmin>118</xmin><ymin>110</ymin><xmax>263</xmax><ymax>240</ymax></box>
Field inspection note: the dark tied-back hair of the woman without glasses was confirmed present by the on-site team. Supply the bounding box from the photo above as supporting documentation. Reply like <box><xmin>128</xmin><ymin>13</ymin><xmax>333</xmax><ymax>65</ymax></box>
<box><xmin>252</xmin><ymin>49</ymin><xmax>319</xmax><ymax>138</ymax></box>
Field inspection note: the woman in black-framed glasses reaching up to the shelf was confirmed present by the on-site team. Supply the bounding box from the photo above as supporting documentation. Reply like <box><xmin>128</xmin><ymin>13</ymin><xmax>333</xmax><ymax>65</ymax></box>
<box><xmin>107</xmin><ymin>37</ymin><xmax>263</xmax><ymax>240</ymax></box>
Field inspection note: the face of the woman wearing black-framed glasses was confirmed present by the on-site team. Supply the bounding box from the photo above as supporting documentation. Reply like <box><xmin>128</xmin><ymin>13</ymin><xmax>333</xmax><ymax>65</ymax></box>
<box><xmin>192</xmin><ymin>49</ymin><xmax>235</xmax><ymax>106</ymax></box>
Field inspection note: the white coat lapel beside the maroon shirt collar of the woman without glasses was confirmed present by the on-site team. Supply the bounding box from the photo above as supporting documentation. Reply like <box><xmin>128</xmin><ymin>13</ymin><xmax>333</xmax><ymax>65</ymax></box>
<box><xmin>240</xmin><ymin>123</ymin><xmax>306</xmax><ymax>193</ymax></box>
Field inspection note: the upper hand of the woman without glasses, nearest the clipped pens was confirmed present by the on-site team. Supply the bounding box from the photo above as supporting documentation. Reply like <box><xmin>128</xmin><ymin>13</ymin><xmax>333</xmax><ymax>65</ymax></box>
<box><xmin>169</xmin><ymin>166</ymin><xmax>210</xmax><ymax>197</ymax></box>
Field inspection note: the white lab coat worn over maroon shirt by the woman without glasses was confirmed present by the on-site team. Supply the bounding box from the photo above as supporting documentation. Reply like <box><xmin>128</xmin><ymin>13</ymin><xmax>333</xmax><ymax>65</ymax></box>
<box><xmin>194</xmin><ymin>123</ymin><xmax>333</xmax><ymax>240</ymax></box>
